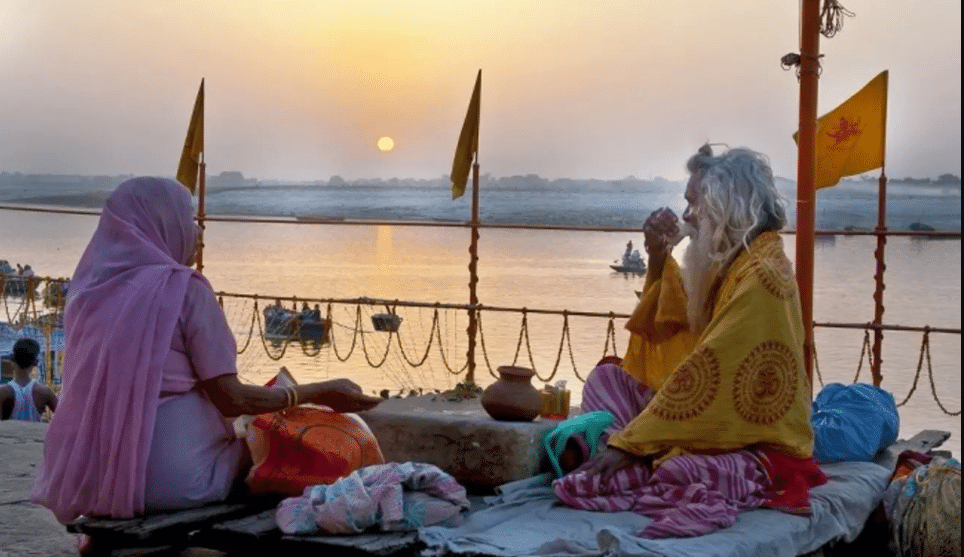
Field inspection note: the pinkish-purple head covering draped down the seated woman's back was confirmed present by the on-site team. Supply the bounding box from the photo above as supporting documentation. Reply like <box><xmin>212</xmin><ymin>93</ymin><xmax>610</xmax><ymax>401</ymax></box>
<box><xmin>32</xmin><ymin>178</ymin><xmax>207</xmax><ymax>522</ymax></box>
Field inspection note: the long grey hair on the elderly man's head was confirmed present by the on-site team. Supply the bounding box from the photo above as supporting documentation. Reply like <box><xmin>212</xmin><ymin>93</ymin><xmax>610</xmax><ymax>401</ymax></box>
<box><xmin>686</xmin><ymin>144</ymin><xmax>787</xmax><ymax>267</ymax></box>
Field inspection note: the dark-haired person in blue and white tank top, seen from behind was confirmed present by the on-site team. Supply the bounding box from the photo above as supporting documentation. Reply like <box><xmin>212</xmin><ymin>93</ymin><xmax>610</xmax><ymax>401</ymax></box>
<box><xmin>0</xmin><ymin>338</ymin><xmax>57</xmax><ymax>422</ymax></box>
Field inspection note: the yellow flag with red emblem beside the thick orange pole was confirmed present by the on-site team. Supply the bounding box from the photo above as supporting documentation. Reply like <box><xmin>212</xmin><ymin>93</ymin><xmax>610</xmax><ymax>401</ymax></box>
<box><xmin>794</xmin><ymin>70</ymin><xmax>888</xmax><ymax>189</ymax></box>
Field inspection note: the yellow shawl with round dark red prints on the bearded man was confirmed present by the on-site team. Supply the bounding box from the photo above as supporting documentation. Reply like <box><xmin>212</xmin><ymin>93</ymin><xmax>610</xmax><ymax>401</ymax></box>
<box><xmin>609</xmin><ymin>232</ymin><xmax>813</xmax><ymax>465</ymax></box>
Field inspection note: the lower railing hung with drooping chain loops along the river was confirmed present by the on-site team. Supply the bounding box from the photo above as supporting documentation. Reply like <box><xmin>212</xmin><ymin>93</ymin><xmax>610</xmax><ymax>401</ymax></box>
<box><xmin>7</xmin><ymin>275</ymin><xmax>961</xmax><ymax>416</ymax></box>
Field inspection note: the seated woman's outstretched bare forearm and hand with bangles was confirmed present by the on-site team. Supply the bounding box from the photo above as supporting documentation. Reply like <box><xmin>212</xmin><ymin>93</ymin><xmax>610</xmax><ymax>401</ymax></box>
<box><xmin>200</xmin><ymin>373</ymin><xmax>382</xmax><ymax>418</ymax></box>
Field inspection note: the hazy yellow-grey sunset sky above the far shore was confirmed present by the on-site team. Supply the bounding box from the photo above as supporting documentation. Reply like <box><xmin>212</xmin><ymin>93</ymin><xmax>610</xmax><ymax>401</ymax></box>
<box><xmin>0</xmin><ymin>0</ymin><xmax>961</xmax><ymax>180</ymax></box>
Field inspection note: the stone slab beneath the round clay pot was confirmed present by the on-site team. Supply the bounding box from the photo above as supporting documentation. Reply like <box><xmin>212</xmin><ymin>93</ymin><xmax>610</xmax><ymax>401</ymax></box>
<box><xmin>359</xmin><ymin>395</ymin><xmax>572</xmax><ymax>488</ymax></box>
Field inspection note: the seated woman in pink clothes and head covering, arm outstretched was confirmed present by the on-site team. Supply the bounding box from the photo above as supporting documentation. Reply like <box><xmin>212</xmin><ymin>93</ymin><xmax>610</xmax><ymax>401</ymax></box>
<box><xmin>31</xmin><ymin>177</ymin><xmax>381</xmax><ymax>528</ymax></box>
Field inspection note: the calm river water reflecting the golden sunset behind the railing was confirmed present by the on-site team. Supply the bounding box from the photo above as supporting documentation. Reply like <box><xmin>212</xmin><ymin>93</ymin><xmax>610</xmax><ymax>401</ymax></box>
<box><xmin>0</xmin><ymin>182</ymin><xmax>961</xmax><ymax>455</ymax></box>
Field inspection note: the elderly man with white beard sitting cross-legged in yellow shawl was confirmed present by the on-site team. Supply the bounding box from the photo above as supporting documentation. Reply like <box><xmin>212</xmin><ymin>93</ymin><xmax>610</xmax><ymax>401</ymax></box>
<box><xmin>553</xmin><ymin>145</ymin><xmax>826</xmax><ymax>537</ymax></box>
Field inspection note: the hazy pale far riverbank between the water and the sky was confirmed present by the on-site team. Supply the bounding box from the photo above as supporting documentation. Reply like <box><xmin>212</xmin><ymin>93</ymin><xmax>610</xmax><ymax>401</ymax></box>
<box><xmin>0</xmin><ymin>181</ymin><xmax>961</xmax><ymax>232</ymax></box>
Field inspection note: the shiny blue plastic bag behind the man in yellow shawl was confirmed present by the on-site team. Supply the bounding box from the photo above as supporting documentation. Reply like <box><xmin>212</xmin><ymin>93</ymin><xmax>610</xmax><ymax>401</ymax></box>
<box><xmin>810</xmin><ymin>383</ymin><xmax>900</xmax><ymax>463</ymax></box>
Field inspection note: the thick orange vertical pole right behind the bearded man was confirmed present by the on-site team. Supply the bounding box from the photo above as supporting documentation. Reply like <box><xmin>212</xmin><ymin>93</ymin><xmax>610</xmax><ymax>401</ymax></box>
<box><xmin>796</xmin><ymin>0</ymin><xmax>820</xmax><ymax>390</ymax></box>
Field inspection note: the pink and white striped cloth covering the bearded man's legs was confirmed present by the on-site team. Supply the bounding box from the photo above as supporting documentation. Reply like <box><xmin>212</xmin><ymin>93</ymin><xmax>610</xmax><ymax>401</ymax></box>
<box><xmin>553</xmin><ymin>364</ymin><xmax>770</xmax><ymax>538</ymax></box>
